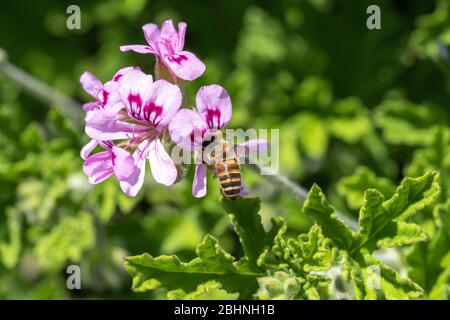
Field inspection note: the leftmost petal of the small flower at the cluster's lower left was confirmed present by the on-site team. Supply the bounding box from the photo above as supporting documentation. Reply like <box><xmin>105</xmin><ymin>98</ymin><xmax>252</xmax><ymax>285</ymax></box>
<box><xmin>83</xmin><ymin>151</ymin><xmax>113</xmax><ymax>184</ymax></box>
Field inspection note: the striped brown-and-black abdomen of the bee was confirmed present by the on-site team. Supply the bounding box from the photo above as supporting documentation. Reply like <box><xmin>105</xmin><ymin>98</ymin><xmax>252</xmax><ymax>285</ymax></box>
<box><xmin>215</xmin><ymin>159</ymin><xmax>241</xmax><ymax>199</ymax></box>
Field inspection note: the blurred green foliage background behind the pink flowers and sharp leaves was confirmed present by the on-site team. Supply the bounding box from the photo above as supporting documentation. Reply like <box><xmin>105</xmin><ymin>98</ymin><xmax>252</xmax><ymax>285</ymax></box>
<box><xmin>0</xmin><ymin>0</ymin><xmax>450</xmax><ymax>299</ymax></box>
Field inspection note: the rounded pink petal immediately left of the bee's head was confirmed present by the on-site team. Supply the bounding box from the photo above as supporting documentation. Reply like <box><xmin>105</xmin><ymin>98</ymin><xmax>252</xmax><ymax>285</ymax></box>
<box><xmin>169</xmin><ymin>109</ymin><xmax>207</xmax><ymax>151</ymax></box>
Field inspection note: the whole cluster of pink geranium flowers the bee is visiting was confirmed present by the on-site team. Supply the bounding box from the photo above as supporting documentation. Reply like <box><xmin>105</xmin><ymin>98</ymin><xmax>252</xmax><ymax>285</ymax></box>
<box><xmin>80</xmin><ymin>20</ymin><xmax>265</xmax><ymax>197</ymax></box>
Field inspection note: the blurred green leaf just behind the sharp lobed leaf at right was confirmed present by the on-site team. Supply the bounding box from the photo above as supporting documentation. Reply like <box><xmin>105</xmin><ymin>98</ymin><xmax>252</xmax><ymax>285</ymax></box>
<box><xmin>337</xmin><ymin>167</ymin><xmax>395</xmax><ymax>210</ymax></box>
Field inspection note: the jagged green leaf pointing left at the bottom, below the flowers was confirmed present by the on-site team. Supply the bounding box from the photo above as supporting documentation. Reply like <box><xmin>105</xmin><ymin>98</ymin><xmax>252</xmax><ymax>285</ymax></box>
<box><xmin>125</xmin><ymin>235</ymin><xmax>263</xmax><ymax>299</ymax></box>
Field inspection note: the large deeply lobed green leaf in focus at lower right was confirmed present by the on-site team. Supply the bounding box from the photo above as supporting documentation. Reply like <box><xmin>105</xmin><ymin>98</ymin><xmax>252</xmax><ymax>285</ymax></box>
<box><xmin>303</xmin><ymin>172</ymin><xmax>440</xmax><ymax>299</ymax></box>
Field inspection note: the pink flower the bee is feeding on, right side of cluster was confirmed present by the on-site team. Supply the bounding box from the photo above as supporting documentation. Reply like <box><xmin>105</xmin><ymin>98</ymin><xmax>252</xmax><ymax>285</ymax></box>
<box><xmin>169</xmin><ymin>84</ymin><xmax>267</xmax><ymax>197</ymax></box>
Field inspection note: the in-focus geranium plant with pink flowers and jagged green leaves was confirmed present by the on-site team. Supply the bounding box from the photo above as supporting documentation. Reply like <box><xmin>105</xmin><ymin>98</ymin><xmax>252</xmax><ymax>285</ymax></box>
<box><xmin>80</xmin><ymin>20</ymin><xmax>448</xmax><ymax>299</ymax></box>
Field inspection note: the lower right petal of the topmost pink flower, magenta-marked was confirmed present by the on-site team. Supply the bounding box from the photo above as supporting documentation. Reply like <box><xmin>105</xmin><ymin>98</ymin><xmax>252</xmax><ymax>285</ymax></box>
<box><xmin>163</xmin><ymin>51</ymin><xmax>206</xmax><ymax>81</ymax></box>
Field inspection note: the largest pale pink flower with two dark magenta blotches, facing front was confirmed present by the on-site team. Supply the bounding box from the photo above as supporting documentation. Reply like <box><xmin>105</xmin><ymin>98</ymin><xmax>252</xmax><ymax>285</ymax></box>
<box><xmin>82</xmin><ymin>69</ymin><xmax>182</xmax><ymax>196</ymax></box>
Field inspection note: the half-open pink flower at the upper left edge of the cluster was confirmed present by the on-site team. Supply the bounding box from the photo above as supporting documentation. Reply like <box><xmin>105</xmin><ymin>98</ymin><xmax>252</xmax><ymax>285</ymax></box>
<box><xmin>80</xmin><ymin>67</ymin><xmax>139</xmax><ymax>116</ymax></box>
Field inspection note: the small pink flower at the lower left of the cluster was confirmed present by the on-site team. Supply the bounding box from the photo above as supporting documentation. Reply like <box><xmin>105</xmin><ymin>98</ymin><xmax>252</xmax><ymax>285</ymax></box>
<box><xmin>81</xmin><ymin>140</ymin><xmax>134</xmax><ymax>184</ymax></box>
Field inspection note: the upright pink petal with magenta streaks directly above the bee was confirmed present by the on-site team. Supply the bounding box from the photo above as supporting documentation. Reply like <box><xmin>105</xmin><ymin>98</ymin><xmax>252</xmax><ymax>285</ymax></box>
<box><xmin>196</xmin><ymin>84</ymin><xmax>232</xmax><ymax>129</ymax></box>
